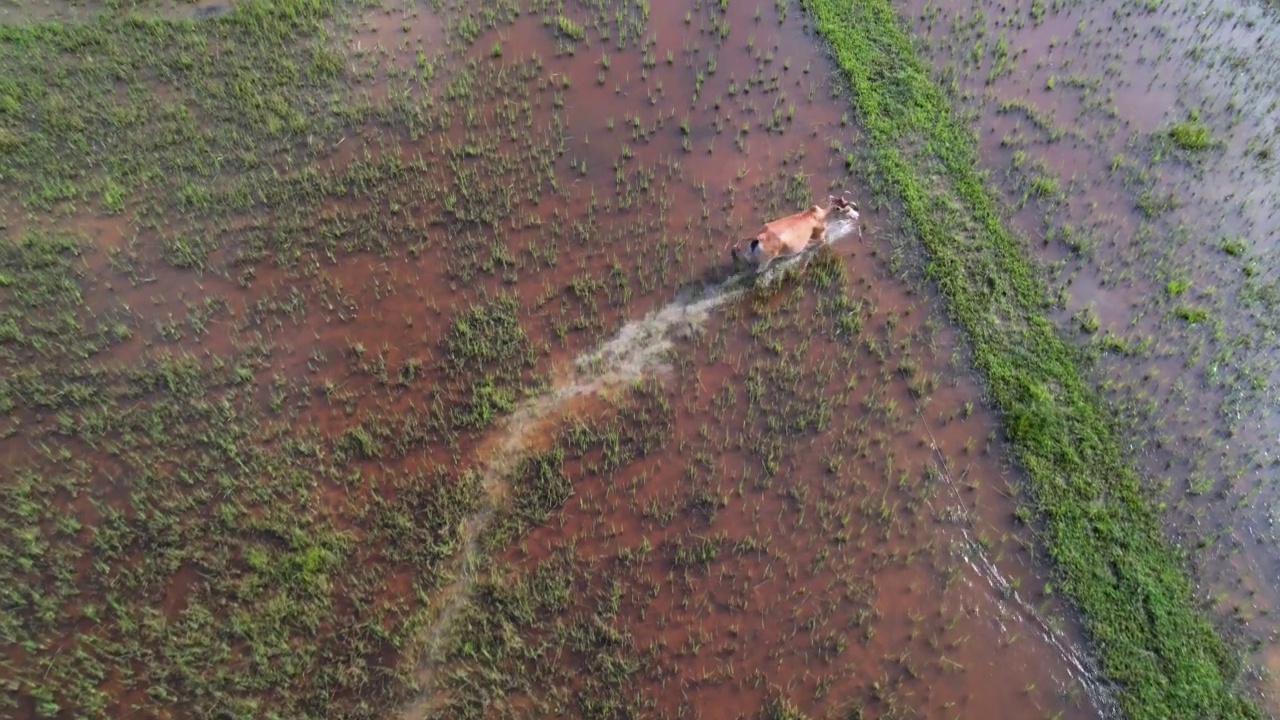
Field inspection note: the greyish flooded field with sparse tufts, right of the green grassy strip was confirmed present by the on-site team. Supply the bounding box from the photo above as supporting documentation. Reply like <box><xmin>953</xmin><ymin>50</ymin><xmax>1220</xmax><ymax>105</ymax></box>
<box><xmin>901</xmin><ymin>1</ymin><xmax>1280</xmax><ymax>710</ymax></box>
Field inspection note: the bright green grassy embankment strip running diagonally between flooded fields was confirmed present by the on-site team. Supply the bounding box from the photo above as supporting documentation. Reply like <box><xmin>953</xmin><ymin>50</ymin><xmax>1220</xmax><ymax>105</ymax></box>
<box><xmin>804</xmin><ymin>0</ymin><xmax>1262</xmax><ymax>719</ymax></box>
